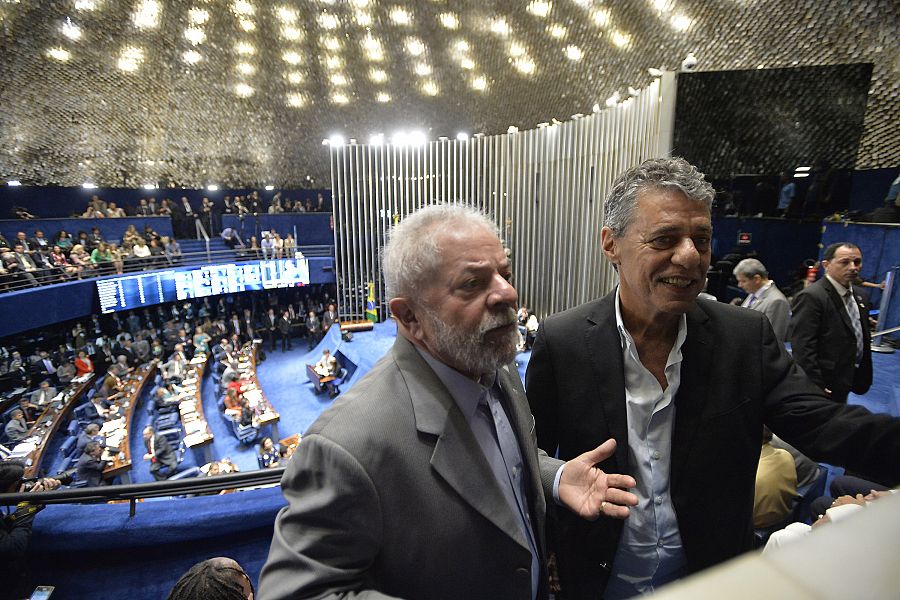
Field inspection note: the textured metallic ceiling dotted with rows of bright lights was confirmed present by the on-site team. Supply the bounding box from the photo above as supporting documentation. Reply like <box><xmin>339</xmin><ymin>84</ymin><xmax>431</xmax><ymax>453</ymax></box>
<box><xmin>0</xmin><ymin>0</ymin><xmax>900</xmax><ymax>187</ymax></box>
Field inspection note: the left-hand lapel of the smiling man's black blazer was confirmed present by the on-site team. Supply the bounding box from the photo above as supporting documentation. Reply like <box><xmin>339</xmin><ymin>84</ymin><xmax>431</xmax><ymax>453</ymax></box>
<box><xmin>584</xmin><ymin>292</ymin><xmax>630</xmax><ymax>473</ymax></box>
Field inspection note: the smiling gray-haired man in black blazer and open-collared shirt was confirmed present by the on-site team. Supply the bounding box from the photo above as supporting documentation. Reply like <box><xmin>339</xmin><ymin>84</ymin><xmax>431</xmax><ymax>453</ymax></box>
<box><xmin>527</xmin><ymin>158</ymin><xmax>900</xmax><ymax>600</ymax></box>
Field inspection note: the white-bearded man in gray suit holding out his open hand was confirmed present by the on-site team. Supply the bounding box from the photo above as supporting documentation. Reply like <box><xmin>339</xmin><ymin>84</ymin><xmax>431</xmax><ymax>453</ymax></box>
<box><xmin>259</xmin><ymin>206</ymin><xmax>636</xmax><ymax>600</ymax></box>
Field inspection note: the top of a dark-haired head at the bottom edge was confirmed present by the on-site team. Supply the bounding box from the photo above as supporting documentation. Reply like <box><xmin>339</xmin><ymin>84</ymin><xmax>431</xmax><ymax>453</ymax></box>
<box><xmin>167</xmin><ymin>556</ymin><xmax>253</xmax><ymax>600</ymax></box>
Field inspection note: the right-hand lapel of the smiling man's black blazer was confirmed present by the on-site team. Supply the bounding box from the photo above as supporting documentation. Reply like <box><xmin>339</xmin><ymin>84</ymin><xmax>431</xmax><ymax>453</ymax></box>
<box><xmin>671</xmin><ymin>302</ymin><xmax>715</xmax><ymax>489</ymax></box>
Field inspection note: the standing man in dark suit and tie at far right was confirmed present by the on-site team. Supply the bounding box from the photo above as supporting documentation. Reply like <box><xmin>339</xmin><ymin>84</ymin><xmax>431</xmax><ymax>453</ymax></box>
<box><xmin>791</xmin><ymin>242</ymin><xmax>872</xmax><ymax>403</ymax></box>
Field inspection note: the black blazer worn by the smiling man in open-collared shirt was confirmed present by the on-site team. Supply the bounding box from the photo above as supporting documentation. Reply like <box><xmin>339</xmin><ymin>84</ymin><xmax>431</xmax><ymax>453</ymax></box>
<box><xmin>526</xmin><ymin>293</ymin><xmax>900</xmax><ymax>598</ymax></box>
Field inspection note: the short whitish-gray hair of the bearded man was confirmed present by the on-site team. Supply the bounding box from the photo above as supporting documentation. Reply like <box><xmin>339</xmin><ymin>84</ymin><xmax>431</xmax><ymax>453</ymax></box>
<box><xmin>381</xmin><ymin>204</ymin><xmax>499</xmax><ymax>299</ymax></box>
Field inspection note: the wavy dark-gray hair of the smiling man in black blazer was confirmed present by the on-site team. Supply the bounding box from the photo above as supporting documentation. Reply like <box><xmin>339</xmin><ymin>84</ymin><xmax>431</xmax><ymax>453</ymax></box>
<box><xmin>603</xmin><ymin>157</ymin><xmax>716</xmax><ymax>237</ymax></box>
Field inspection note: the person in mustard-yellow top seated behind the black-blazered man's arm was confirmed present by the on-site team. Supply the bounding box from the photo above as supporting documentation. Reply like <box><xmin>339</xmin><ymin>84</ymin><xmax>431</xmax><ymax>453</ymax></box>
<box><xmin>753</xmin><ymin>426</ymin><xmax>797</xmax><ymax>529</ymax></box>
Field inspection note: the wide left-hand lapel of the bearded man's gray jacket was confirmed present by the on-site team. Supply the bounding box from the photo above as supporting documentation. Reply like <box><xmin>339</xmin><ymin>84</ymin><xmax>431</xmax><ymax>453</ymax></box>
<box><xmin>393</xmin><ymin>335</ymin><xmax>540</xmax><ymax>549</ymax></box>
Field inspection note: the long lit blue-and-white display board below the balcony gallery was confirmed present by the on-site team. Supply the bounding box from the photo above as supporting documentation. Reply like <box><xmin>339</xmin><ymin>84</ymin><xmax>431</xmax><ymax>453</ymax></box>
<box><xmin>97</xmin><ymin>258</ymin><xmax>309</xmax><ymax>314</ymax></box>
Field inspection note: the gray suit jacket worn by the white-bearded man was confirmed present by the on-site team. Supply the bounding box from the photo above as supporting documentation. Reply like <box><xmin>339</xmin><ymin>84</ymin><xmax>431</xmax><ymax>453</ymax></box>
<box><xmin>259</xmin><ymin>336</ymin><xmax>562</xmax><ymax>600</ymax></box>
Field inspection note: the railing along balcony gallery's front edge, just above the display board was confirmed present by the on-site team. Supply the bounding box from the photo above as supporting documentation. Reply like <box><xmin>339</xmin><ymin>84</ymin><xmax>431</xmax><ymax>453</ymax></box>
<box><xmin>0</xmin><ymin>242</ymin><xmax>334</xmax><ymax>294</ymax></box>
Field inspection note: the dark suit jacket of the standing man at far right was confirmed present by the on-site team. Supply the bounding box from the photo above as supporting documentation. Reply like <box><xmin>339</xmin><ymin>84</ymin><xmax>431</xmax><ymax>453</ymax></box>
<box><xmin>791</xmin><ymin>277</ymin><xmax>872</xmax><ymax>402</ymax></box>
